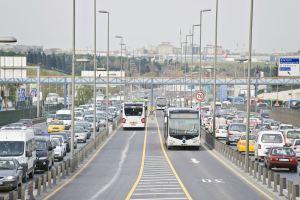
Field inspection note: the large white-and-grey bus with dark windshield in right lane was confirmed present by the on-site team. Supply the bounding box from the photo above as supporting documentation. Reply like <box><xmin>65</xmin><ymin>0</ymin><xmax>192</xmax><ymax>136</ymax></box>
<box><xmin>164</xmin><ymin>108</ymin><xmax>200</xmax><ymax>150</ymax></box>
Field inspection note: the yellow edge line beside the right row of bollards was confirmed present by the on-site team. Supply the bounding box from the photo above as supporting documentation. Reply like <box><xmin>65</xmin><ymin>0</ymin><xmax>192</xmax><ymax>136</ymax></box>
<box><xmin>202</xmin><ymin>145</ymin><xmax>274</xmax><ymax>200</ymax></box>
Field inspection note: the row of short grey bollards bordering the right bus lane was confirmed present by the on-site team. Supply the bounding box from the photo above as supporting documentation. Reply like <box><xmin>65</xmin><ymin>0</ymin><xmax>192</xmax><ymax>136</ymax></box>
<box><xmin>201</xmin><ymin>130</ymin><xmax>300</xmax><ymax>200</ymax></box>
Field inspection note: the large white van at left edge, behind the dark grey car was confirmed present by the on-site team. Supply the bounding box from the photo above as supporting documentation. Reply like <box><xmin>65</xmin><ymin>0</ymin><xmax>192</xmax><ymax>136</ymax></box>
<box><xmin>0</xmin><ymin>127</ymin><xmax>36</xmax><ymax>181</ymax></box>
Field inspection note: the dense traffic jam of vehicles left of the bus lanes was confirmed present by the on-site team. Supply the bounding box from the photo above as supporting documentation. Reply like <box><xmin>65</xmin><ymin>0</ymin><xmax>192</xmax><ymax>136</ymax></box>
<box><xmin>0</xmin><ymin>101</ymin><xmax>121</xmax><ymax>192</ymax></box>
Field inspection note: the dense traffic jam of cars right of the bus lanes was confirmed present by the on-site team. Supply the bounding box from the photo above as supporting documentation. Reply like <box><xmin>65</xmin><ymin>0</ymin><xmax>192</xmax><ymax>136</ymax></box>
<box><xmin>201</xmin><ymin>101</ymin><xmax>300</xmax><ymax>173</ymax></box>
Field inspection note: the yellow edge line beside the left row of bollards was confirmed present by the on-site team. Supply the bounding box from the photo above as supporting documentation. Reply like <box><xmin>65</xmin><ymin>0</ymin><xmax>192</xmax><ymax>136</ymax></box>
<box><xmin>43</xmin><ymin>125</ymin><xmax>121</xmax><ymax>200</ymax></box>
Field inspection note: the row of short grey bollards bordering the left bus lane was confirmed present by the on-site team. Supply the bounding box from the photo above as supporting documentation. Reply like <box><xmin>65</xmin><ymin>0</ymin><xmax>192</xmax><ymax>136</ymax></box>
<box><xmin>0</xmin><ymin>117</ymin><xmax>121</xmax><ymax>200</ymax></box>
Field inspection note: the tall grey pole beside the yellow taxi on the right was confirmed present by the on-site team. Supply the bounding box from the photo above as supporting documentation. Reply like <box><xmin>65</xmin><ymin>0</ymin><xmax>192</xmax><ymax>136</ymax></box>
<box><xmin>245</xmin><ymin>0</ymin><xmax>254</xmax><ymax>172</ymax></box>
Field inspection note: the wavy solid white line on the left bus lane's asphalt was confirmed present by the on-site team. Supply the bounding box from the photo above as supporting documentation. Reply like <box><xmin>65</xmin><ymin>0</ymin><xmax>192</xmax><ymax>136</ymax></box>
<box><xmin>89</xmin><ymin>131</ymin><xmax>136</xmax><ymax>200</ymax></box>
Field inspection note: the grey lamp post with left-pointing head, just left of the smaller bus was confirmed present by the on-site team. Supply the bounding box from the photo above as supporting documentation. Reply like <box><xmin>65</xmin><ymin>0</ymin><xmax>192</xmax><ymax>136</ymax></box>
<box><xmin>99</xmin><ymin>10</ymin><xmax>109</xmax><ymax>131</ymax></box>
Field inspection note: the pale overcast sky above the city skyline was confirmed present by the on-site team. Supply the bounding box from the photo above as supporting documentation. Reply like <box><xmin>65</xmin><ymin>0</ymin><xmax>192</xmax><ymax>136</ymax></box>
<box><xmin>0</xmin><ymin>0</ymin><xmax>300</xmax><ymax>53</ymax></box>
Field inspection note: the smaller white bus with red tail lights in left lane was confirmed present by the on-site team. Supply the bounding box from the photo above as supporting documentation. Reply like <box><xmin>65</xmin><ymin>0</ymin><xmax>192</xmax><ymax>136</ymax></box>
<box><xmin>122</xmin><ymin>102</ymin><xmax>146</xmax><ymax>130</ymax></box>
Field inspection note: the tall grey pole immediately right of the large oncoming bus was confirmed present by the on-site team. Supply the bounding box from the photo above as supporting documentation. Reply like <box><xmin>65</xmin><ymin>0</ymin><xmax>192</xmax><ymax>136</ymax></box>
<box><xmin>213</xmin><ymin>0</ymin><xmax>219</xmax><ymax>146</ymax></box>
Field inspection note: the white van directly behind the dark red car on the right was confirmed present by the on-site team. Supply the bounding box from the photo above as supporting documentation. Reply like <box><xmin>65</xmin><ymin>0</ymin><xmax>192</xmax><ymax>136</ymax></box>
<box><xmin>254</xmin><ymin>131</ymin><xmax>285</xmax><ymax>160</ymax></box>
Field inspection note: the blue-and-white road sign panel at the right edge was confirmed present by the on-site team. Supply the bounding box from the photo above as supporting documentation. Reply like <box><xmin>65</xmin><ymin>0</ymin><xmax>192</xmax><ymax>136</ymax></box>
<box><xmin>278</xmin><ymin>57</ymin><xmax>300</xmax><ymax>77</ymax></box>
